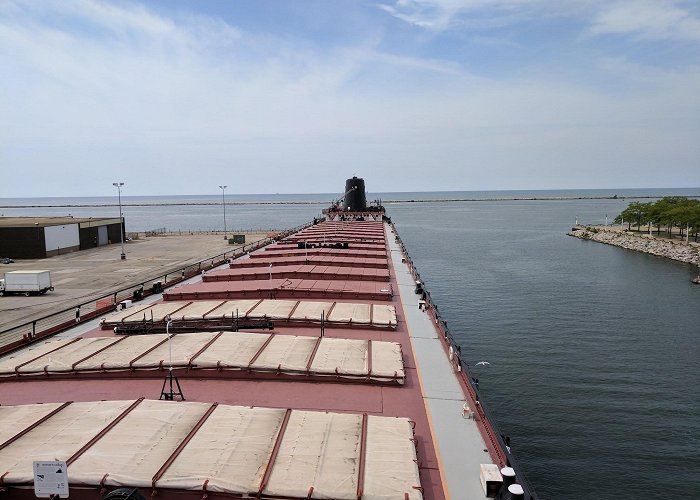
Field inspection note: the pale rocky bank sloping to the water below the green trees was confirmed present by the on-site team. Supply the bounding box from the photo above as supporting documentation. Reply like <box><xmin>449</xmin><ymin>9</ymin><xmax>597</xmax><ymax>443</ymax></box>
<box><xmin>566</xmin><ymin>226</ymin><xmax>700</xmax><ymax>266</ymax></box>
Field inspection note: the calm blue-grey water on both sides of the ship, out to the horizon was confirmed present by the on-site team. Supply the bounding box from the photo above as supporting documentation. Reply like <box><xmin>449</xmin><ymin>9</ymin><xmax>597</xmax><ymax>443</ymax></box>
<box><xmin>0</xmin><ymin>189</ymin><xmax>700</xmax><ymax>500</ymax></box>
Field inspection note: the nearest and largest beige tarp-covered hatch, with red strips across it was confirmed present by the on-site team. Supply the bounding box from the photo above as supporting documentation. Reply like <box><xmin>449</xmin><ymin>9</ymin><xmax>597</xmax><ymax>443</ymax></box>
<box><xmin>0</xmin><ymin>399</ymin><xmax>423</xmax><ymax>500</ymax></box>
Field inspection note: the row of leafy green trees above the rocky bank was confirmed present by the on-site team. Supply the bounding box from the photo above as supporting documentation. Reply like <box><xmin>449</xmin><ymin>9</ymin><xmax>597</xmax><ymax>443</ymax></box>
<box><xmin>615</xmin><ymin>196</ymin><xmax>700</xmax><ymax>241</ymax></box>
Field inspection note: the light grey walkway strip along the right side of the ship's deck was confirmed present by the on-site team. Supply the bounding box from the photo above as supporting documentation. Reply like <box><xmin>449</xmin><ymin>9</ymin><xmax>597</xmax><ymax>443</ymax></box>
<box><xmin>386</xmin><ymin>225</ymin><xmax>492</xmax><ymax>499</ymax></box>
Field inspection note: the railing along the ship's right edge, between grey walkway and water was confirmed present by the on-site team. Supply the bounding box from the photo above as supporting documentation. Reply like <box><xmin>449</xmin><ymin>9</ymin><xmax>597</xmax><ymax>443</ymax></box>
<box><xmin>389</xmin><ymin>221</ymin><xmax>539</xmax><ymax>500</ymax></box>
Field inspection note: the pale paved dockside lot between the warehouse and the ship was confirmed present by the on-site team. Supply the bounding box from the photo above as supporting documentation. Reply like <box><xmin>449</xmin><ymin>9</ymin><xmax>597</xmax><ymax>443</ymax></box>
<box><xmin>0</xmin><ymin>233</ymin><xmax>266</xmax><ymax>330</ymax></box>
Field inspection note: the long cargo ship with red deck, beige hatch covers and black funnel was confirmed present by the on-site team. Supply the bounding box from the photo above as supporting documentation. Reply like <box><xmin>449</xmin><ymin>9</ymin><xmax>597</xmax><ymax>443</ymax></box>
<box><xmin>0</xmin><ymin>178</ymin><xmax>522</xmax><ymax>500</ymax></box>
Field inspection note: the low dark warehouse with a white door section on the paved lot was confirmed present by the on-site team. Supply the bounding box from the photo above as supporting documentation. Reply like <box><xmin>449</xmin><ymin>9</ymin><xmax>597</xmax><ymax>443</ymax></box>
<box><xmin>0</xmin><ymin>217</ymin><xmax>126</xmax><ymax>259</ymax></box>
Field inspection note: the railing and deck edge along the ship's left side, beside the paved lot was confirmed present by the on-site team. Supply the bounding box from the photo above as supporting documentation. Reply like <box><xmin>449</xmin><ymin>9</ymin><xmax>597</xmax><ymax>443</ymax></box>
<box><xmin>0</xmin><ymin>222</ymin><xmax>313</xmax><ymax>354</ymax></box>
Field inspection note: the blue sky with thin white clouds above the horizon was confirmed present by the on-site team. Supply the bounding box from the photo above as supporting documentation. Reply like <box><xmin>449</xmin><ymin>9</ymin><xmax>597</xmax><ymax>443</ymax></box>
<box><xmin>0</xmin><ymin>0</ymin><xmax>700</xmax><ymax>198</ymax></box>
